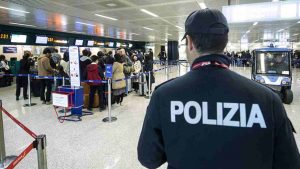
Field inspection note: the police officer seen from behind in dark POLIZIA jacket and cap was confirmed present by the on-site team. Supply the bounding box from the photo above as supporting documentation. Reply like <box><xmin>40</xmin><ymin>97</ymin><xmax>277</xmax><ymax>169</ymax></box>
<box><xmin>138</xmin><ymin>9</ymin><xmax>300</xmax><ymax>169</ymax></box>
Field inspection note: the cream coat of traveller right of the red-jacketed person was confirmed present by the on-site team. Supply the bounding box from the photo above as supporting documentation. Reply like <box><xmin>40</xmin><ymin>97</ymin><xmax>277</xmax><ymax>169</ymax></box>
<box><xmin>112</xmin><ymin>62</ymin><xmax>126</xmax><ymax>89</ymax></box>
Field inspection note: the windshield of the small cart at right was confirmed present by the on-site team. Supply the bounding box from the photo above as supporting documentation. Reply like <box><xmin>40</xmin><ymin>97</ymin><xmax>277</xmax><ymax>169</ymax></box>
<box><xmin>256</xmin><ymin>52</ymin><xmax>290</xmax><ymax>75</ymax></box>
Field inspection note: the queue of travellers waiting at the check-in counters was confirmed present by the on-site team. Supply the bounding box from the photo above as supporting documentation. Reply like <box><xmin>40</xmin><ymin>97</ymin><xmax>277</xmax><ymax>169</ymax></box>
<box><xmin>0</xmin><ymin>48</ymin><xmax>155</xmax><ymax>111</ymax></box>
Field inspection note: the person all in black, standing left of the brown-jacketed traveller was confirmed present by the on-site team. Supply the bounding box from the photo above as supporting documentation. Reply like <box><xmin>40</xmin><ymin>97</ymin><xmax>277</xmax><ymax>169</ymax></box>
<box><xmin>16</xmin><ymin>51</ymin><xmax>33</xmax><ymax>100</ymax></box>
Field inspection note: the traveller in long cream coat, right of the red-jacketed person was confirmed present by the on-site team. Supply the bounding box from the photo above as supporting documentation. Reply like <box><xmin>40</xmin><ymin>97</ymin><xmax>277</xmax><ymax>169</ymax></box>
<box><xmin>112</xmin><ymin>53</ymin><xmax>126</xmax><ymax>105</ymax></box>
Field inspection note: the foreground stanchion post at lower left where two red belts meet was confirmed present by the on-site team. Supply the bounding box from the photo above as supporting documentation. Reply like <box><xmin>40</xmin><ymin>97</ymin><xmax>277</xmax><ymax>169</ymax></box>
<box><xmin>36</xmin><ymin>135</ymin><xmax>47</xmax><ymax>169</ymax></box>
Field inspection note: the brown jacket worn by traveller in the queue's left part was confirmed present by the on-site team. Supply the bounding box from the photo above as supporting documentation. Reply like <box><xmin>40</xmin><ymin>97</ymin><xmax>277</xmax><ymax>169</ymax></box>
<box><xmin>38</xmin><ymin>55</ymin><xmax>54</xmax><ymax>76</ymax></box>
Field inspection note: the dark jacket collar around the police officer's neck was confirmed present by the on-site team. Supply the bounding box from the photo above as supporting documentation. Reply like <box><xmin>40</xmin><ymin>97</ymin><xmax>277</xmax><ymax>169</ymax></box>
<box><xmin>192</xmin><ymin>54</ymin><xmax>231</xmax><ymax>67</ymax></box>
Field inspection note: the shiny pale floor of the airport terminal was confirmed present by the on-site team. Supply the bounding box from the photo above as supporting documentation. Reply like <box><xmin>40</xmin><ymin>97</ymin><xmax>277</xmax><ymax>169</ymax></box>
<box><xmin>0</xmin><ymin>67</ymin><xmax>300</xmax><ymax>169</ymax></box>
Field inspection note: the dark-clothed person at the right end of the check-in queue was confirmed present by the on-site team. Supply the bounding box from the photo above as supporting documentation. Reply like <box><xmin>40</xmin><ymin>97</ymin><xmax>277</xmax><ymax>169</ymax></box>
<box><xmin>144</xmin><ymin>54</ymin><xmax>155</xmax><ymax>94</ymax></box>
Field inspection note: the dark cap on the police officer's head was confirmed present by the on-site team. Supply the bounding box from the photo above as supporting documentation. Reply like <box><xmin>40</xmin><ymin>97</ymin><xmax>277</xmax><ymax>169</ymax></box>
<box><xmin>182</xmin><ymin>8</ymin><xmax>229</xmax><ymax>40</ymax></box>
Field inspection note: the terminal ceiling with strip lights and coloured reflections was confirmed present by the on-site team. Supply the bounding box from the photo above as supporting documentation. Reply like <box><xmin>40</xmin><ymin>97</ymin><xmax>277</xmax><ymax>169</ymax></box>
<box><xmin>0</xmin><ymin>0</ymin><xmax>300</xmax><ymax>42</ymax></box>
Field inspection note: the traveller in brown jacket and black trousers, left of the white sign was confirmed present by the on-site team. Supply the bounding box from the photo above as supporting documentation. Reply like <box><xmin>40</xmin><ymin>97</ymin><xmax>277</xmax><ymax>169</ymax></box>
<box><xmin>38</xmin><ymin>48</ymin><xmax>55</xmax><ymax>105</ymax></box>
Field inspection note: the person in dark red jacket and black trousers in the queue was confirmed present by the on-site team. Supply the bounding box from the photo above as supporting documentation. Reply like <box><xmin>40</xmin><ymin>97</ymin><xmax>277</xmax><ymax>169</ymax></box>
<box><xmin>86</xmin><ymin>55</ymin><xmax>105</xmax><ymax>112</ymax></box>
